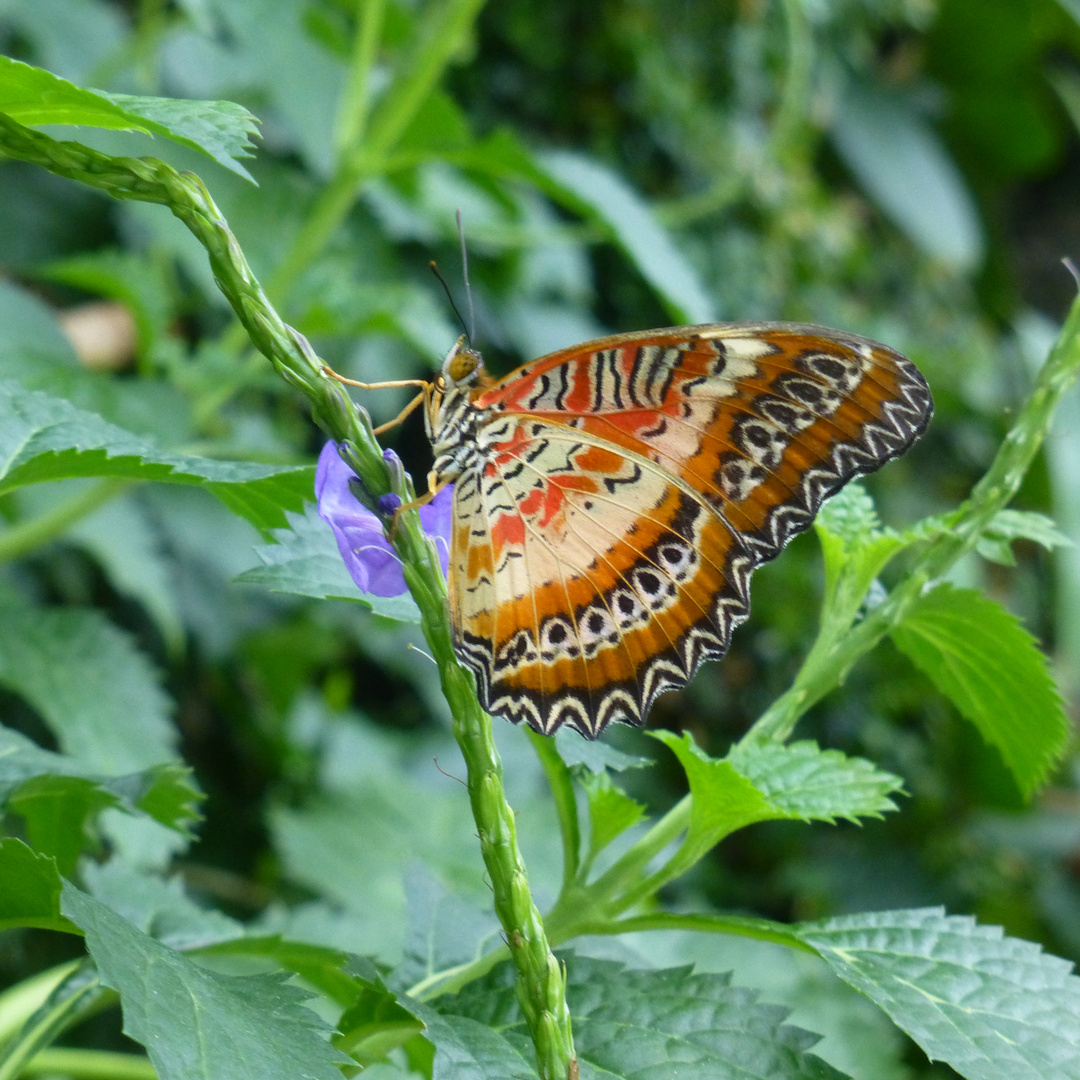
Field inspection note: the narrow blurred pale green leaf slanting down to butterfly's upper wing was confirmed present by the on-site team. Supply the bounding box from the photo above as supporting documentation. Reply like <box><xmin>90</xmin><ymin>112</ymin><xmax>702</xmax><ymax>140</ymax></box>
<box><xmin>539</xmin><ymin>151</ymin><xmax>714</xmax><ymax>323</ymax></box>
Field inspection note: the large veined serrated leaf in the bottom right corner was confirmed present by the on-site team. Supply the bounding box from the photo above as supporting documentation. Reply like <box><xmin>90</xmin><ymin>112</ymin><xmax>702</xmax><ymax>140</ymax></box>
<box><xmin>796</xmin><ymin>908</ymin><xmax>1080</xmax><ymax>1080</ymax></box>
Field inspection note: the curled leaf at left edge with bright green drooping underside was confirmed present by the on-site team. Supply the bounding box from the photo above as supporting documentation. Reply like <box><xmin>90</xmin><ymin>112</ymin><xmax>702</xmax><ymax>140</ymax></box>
<box><xmin>0</xmin><ymin>728</ymin><xmax>202</xmax><ymax>874</ymax></box>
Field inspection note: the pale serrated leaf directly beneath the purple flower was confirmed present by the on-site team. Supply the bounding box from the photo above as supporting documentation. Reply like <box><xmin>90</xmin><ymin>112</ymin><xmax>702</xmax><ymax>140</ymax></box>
<box><xmin>234</xmin><ymin>507</ymin><xmax>420</xmax><ymax>622</ymax></box>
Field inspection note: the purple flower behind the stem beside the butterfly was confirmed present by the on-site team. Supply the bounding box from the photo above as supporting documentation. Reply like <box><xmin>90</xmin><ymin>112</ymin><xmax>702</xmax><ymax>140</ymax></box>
<box><xmin>315</xmin><ymin>442</ymin><xmax>454</xmax><ymax>596</ymax></box>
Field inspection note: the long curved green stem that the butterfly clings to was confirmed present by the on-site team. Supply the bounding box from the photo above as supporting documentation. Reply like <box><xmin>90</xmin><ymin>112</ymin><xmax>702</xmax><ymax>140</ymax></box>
<box><xmin>0</xmin><ymin>113</ymin><xmax>576</xmax><ymax>1080</ymax></box>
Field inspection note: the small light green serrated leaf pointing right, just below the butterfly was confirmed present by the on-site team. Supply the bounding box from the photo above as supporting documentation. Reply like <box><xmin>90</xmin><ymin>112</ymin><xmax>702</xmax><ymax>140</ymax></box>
<box><xmin>728</xmin><ymin>742</ymin><xmax>904</xmax><ymax>823</ymax></box>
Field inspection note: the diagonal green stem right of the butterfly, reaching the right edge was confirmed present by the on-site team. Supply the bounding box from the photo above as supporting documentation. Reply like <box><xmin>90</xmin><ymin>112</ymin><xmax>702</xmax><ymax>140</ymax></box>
<box><xmin>743</xmin><ymin>291</ymin><xmax>1080</xmax><ymax>744</ymax></box>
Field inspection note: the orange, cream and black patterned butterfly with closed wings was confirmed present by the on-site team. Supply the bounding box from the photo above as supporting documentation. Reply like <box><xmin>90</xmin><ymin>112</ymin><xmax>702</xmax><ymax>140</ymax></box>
<box><xmin>393</xmin><ymin>323</ymin><xmax>933</xmax><ymax>739</ymax></box>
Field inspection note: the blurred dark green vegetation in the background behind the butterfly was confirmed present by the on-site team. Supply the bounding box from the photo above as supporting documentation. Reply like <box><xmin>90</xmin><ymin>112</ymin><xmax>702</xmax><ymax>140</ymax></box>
<box><xmin>0</xmin><ymin>0</ymin><xmax>1080</xmax><ymax>1077</ymax></box>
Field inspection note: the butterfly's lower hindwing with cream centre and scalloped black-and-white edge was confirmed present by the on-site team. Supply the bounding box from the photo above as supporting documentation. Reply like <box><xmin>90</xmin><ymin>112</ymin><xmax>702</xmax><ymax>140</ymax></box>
<box><xmin>450</xmin><ymin>417</ymin><xmax>745</xmax><ymax>737</ymax></box>
